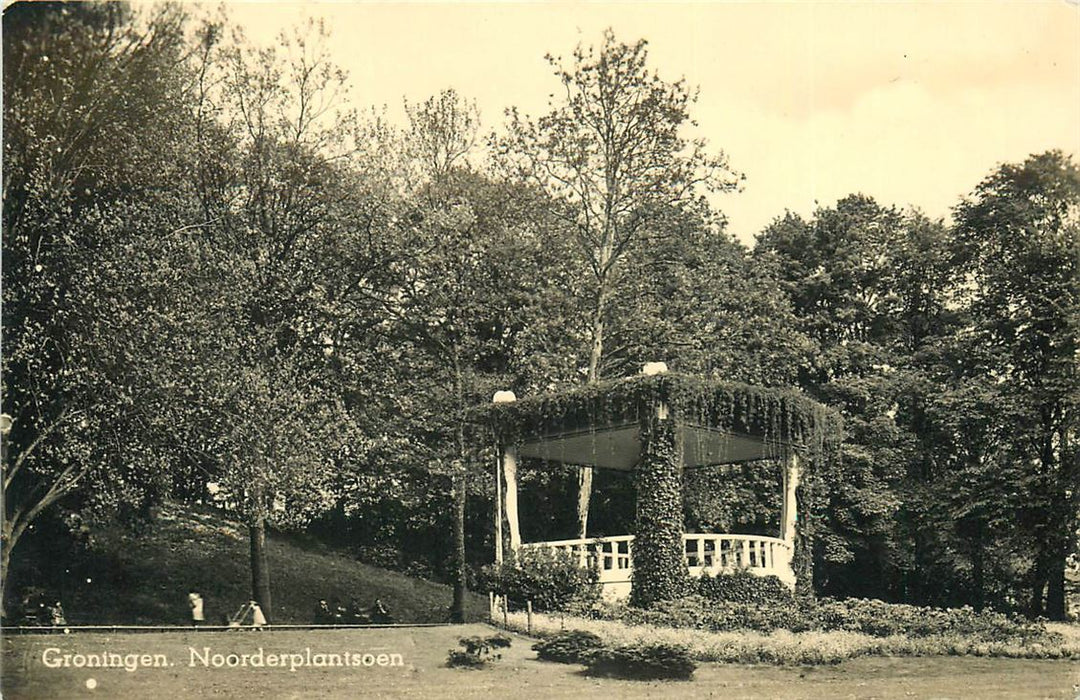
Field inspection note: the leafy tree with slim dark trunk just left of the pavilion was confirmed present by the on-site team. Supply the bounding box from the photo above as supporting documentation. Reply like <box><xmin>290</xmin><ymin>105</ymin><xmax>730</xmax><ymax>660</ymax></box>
<box><xmin>396</xmin><ymin>91</ymin><xmax>583</xmax><ymax>621</ymax></box>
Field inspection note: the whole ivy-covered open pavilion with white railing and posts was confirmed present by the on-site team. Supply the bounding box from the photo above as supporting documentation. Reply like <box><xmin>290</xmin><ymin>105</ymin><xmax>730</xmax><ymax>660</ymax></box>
<box><xmin>477</xmin><ymin>363</ymin><xmax>839</xmax><ymax>605</ymax></box>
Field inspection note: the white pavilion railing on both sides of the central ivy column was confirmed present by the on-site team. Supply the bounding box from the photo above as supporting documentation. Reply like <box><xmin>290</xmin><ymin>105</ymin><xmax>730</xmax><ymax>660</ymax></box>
<box><xmin>522</xmin><ymin>534</ymin><xmax>795</xmax><ymax>585</ymax></box>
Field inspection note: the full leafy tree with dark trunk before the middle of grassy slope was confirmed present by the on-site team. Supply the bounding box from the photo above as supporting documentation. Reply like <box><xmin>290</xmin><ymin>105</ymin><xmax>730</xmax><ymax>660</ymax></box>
<box><xmin>161</xmin><ymin>16</ymin><xmax>390</xmax><ymax>621</ymax></box>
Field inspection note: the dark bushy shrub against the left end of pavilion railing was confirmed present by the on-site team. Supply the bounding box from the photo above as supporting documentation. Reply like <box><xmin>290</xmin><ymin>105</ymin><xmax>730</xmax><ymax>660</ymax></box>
<box><xmin>480</xmin><ymin>549</ymin><xmax>599</xmax><ymax>611</ymax></box>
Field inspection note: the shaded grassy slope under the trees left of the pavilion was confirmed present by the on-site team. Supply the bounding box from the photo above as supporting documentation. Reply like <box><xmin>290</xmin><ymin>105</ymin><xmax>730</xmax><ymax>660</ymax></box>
<box><xmin>49</xmin><ymin>508</ymin><xmax>487</xmax><ymax>624</ymax></box>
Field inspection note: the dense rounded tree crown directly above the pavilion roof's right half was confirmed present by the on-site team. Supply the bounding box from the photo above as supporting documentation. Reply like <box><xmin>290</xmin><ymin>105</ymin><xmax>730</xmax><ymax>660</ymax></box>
<box><xmin>605</xmin><ymin>212</ymin><xmax>811</xmax><ymax>386</ymax></box>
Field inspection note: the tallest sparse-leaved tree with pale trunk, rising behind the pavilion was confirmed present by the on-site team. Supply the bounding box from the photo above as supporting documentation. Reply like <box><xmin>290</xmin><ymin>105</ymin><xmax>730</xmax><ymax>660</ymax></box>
<box><xmin>498</xmin><ymin>30</ymin><xmax>735</xmax><ymax>537</ymax></box>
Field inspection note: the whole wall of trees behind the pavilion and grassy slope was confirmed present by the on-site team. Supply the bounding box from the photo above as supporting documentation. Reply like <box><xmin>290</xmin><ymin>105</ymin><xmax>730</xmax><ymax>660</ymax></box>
<box><xmin>0</xmin><ymin>2</ymin><xmax>1080</xmax><ymax>618</ymax></box>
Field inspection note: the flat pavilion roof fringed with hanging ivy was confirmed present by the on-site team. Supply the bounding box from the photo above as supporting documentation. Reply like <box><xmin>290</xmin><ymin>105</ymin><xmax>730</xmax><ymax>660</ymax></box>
<box><xmin>473</xmin><ymin>373</ymin><xmax>840</xmax><ymax>469</ymax></box>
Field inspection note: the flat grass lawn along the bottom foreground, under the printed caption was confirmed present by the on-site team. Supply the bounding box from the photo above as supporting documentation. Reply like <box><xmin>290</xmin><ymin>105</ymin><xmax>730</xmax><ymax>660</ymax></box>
<box><xmin>0</xmin><ymin>624</ymin><xmax>1080</xmax><ymax>699</ymax></box>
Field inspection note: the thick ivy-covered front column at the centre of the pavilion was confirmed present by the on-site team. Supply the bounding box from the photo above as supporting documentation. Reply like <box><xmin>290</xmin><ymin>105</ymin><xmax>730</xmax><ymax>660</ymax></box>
<box><xmin>631</xmin><ymin>393</ymin><xmax>687</xmax><ymax>607</ymax></box>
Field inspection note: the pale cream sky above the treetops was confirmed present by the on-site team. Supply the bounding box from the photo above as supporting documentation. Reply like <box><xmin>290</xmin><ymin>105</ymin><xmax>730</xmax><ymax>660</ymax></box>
<box><xmin>228</xmin><ymin>0</ymin><xmax>1080</xmax><ymax>243</ymax></box>
